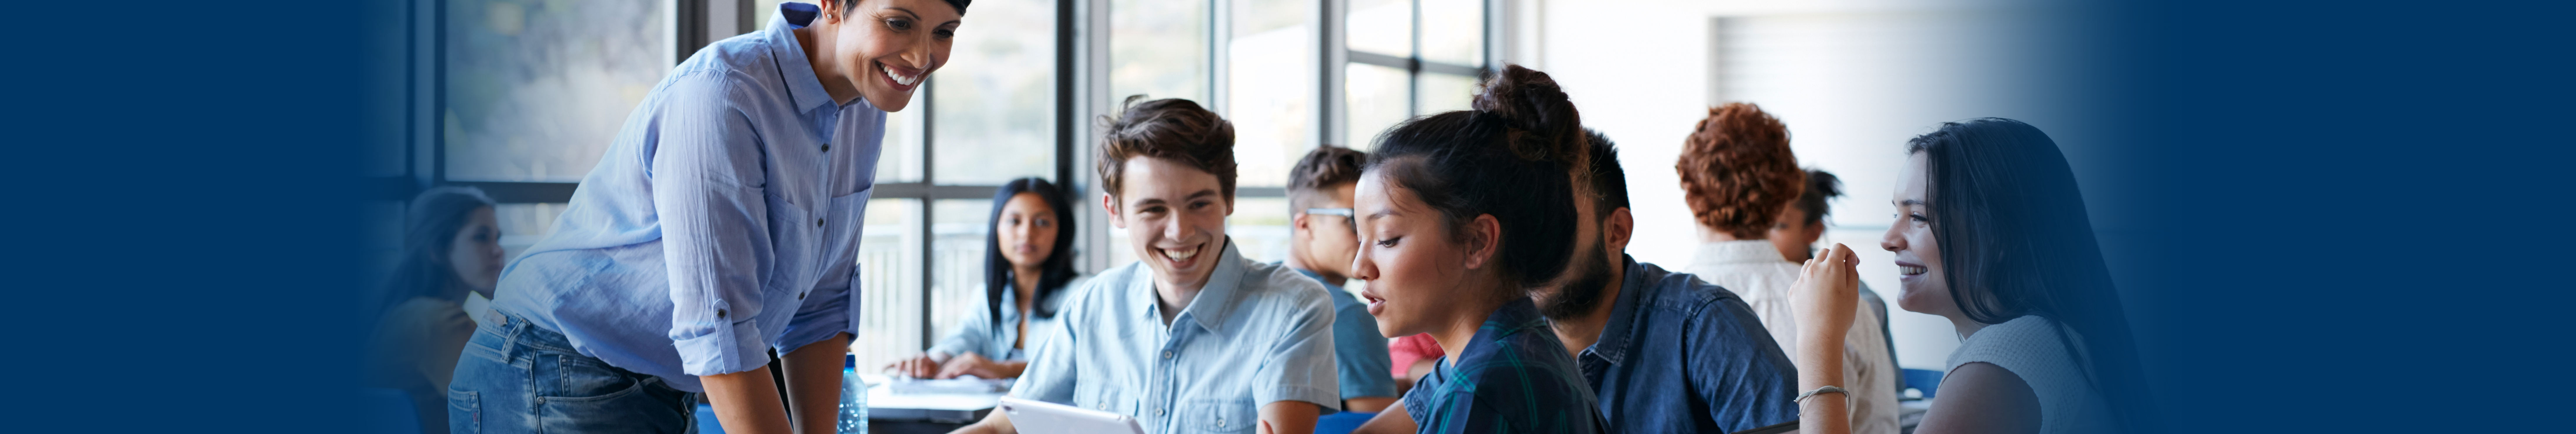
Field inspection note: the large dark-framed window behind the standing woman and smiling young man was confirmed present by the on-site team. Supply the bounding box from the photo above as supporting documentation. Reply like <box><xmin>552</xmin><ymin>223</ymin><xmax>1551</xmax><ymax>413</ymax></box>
<box><xmin>369</xmin><ymin>0</ymin><xmax>1489</xmax><ymax>365</ymax></box>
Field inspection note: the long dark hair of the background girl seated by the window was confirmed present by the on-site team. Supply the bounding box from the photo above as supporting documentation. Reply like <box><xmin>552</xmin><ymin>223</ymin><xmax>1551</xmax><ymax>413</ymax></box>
<box><xmin>984</xmin><ymin>177</ymin><xmax>1079</xmax><ymax>326</ymax></box>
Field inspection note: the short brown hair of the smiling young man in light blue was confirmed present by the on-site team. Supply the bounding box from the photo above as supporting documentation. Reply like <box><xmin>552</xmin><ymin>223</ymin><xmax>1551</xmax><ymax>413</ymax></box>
<box><xmin>1097</xmin><ymin>95</ymin><xmax>1234</xmax><ymax>203</ymax></box>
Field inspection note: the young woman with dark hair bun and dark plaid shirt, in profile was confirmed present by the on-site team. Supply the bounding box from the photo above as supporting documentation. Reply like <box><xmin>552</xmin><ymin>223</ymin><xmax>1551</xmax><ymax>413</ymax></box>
<box><xmin>1353</xmin><ymin>64</ymin><xmax>1602</xmax><ymax>434</ymax></box>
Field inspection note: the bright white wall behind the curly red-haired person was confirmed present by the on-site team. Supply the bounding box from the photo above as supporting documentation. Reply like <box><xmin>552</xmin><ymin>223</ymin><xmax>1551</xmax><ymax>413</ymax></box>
<box><xmin>1512</xmin><ymin>0</ymin><xmax>2084</xmax><ymax>370</ymax></box>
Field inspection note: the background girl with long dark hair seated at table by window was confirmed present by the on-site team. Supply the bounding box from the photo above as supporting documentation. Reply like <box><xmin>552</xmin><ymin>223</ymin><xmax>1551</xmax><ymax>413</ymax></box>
<box><xmin>886</xmin><ymin>177</ymin><xmax>1079</xmax><ymax>378</ymax></box>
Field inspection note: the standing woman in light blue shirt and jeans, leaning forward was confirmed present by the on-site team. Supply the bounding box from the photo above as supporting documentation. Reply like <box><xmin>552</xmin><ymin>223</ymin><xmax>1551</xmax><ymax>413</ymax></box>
<box><xmin>448</xmin><ymin>0</ymin><xmax>966</xmax><ymax>434</ymax></box>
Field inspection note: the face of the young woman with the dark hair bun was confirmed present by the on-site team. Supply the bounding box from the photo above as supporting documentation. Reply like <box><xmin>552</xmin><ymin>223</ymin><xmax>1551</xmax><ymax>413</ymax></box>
<box><xmin>1350</xmin><ymin>172</ymin><xmax>1476</xmax><ymax>337</ymax></box>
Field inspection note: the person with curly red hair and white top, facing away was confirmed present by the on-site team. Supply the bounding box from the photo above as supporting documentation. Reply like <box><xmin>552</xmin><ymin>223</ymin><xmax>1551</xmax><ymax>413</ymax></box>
<box><xmin>1672</xmin><ymin>103</ymin><xmax>1898</xmax><ymax>434</ymax></box>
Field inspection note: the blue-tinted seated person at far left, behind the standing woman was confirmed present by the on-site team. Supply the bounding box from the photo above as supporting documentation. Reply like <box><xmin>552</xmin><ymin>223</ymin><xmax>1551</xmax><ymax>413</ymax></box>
<box><xmin>369</xmin><ymin>188</ymin><xmax>502</xmax><ymax>431</ymax></box>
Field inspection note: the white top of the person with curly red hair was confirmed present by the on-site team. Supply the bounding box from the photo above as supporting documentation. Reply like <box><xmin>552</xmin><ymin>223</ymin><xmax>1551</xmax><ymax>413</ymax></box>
<box><xmin>1682</xmin><ymin>239</ymin><xmax>1898</xmax><ymax>434</ymax></box>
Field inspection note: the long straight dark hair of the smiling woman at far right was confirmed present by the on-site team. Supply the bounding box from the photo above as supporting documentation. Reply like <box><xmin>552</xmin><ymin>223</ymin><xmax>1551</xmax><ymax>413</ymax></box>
<box><xmin>1906</xmin><ymin>118</ymin><xmax>2148</xmax><ymax>431</ymax></box>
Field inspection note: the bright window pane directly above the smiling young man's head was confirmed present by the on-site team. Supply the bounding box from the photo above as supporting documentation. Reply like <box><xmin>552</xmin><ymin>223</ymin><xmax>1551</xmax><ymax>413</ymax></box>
<box><xmin>1105</xmin><ymin>0</ymin><xmax>1211</xmax><ymax>113</ymax></box>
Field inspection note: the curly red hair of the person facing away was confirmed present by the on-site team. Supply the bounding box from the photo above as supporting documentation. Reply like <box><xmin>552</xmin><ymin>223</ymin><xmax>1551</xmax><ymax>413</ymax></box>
<box><xmin>1672</xmin><ymin>103</ymin><xmax>1806</xmax><ymax>239</ymax></box>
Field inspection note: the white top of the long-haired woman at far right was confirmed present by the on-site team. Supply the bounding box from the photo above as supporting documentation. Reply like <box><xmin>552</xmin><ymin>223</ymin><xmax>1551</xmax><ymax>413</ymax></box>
<box><xmin>1950</xmin><ymin>316</ymin><xmax>2112</xmax><ymax>434</ymax></box>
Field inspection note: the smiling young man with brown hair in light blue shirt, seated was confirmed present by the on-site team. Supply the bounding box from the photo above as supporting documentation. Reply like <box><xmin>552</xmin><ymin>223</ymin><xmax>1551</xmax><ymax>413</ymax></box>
<box><xmin>958</xmin><ymin>97</ymin><xmax>1342</xmax><ymax>434</ymax></box>
